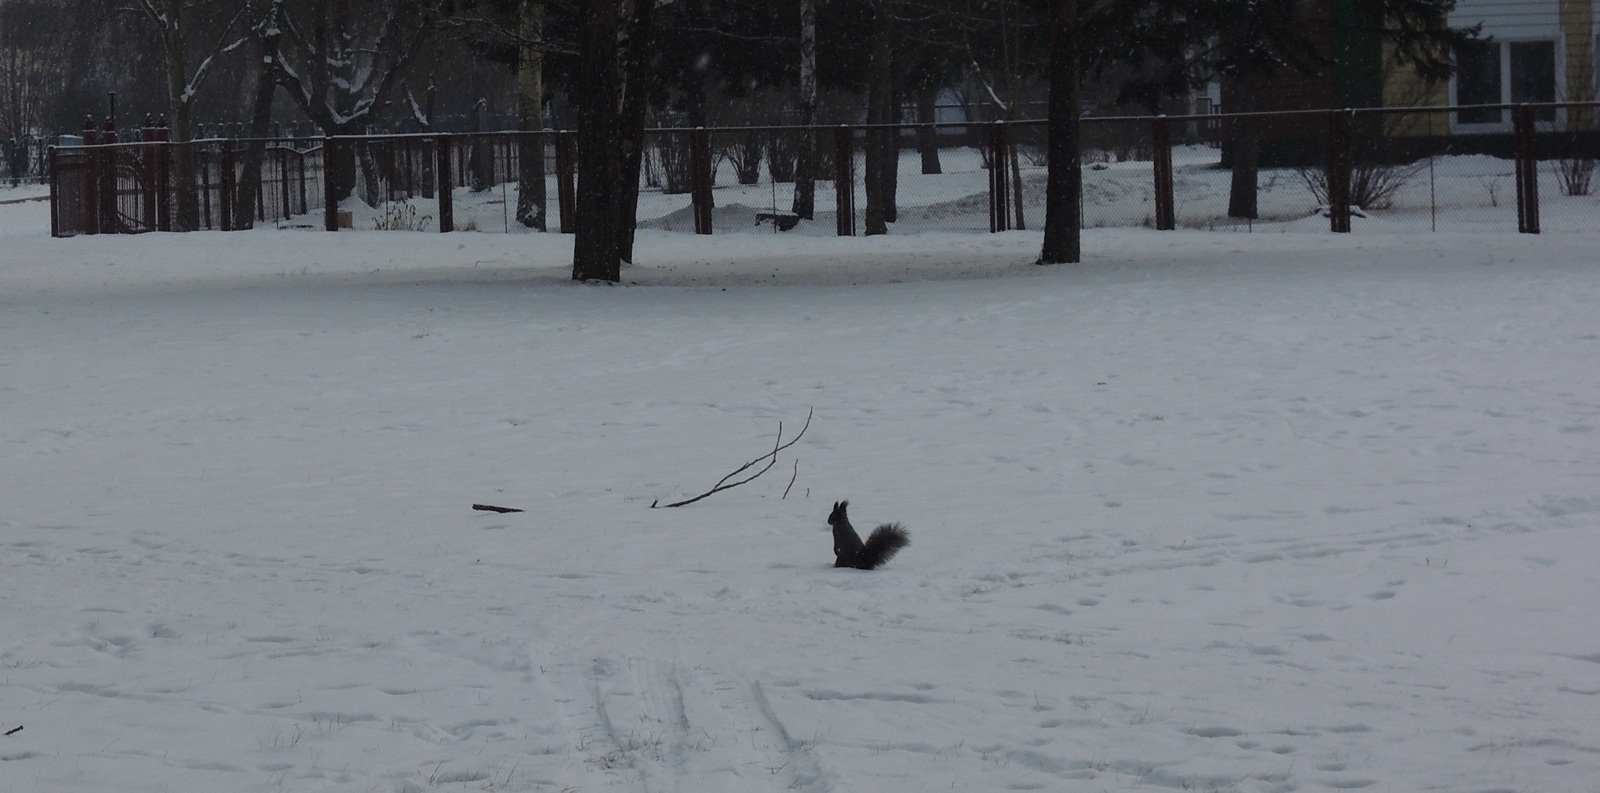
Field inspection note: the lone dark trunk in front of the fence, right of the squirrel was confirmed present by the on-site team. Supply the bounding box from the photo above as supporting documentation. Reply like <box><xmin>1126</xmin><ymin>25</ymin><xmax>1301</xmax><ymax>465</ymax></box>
<box><xmin>1043</xmin><ymin>0</ymin><xmax>1083</xmax><ymax>264</ymax></box>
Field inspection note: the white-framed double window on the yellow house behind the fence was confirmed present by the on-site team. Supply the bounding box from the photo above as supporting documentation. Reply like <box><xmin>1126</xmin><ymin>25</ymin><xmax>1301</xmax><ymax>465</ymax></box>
<box><xmin>1454</xmin><ymin>42</ymin><xmax>1558</xmax><ymax>125</ymax></box>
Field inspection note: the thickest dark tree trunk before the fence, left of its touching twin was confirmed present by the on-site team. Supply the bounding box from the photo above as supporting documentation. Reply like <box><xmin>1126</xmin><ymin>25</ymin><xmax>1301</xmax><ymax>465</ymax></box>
<box><xmin>573</xmin><ymin>0</ymin><xmax>622</xmax><ymax>281</ymax></box>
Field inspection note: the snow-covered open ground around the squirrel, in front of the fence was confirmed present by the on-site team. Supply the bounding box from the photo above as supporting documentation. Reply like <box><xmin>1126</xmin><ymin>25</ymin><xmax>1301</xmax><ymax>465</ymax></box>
<box><xmin>0</xmin><ymin>187</ymin><xmax>1600</xmax><ymax>793</ymax></box>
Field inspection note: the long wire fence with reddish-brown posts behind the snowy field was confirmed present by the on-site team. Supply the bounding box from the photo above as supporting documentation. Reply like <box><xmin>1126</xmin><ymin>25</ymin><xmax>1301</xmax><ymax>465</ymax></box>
<box><xmin>46</xmin><ymin>102</ymin><xmax>1600</xmax><ymax>235</ymax></box>
